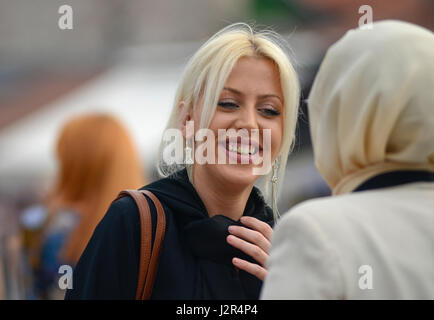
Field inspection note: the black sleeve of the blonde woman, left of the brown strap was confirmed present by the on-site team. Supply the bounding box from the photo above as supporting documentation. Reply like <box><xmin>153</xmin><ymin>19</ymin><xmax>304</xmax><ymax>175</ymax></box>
<box><xmin>65</xmin><ymin>197</ymin><xmax>140</xmax><ymax>300</ymax></box>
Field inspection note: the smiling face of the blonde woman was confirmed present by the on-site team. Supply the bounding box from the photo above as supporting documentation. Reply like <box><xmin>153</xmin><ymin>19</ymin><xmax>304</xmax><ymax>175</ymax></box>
<box><xmin>193</xmin><ymin>57</ymin><xmax>284</xmax><ymax>187</ymax></box>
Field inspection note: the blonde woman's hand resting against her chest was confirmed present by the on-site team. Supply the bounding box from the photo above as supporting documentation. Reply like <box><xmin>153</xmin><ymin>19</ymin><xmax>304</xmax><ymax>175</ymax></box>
<box><xmin>227</xmin><ymin>216</ymin><xmax>273</xmax><ymax>281</ymax></box>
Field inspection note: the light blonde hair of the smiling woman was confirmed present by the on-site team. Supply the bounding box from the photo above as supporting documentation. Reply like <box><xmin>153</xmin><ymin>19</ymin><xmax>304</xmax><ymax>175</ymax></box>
<box><xmin>158</xmin><ymin>23</ymin><xmax>300</xmax><ymax>211</ymax></box>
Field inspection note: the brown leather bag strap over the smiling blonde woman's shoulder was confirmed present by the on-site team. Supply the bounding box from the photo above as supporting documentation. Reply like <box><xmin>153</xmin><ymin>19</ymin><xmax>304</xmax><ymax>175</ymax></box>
<box><xmin>115</xmin><ymin>190</ymin><xmax>166</xmax><ymax>300</ymax></box>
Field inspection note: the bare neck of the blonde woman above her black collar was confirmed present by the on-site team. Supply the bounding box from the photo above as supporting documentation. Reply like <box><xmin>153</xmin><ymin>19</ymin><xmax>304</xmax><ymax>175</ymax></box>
<box><xmin>193</xmin><ymin>169</ymin><xmax>253</xmax><ymax>221</ymax></box>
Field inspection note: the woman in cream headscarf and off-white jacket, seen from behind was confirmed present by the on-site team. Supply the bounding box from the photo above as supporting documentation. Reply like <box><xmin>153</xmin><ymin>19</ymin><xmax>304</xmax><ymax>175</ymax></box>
<box><xmin>261</xmin><ymin>21</ymin><xmax>434</xmax><ymax>299</ymax></box>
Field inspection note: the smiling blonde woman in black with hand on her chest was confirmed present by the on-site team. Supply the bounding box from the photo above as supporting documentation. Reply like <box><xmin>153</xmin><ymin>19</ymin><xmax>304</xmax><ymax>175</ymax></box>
<box><xmin>66</xmin><ymin>24</ymin><xmax>299</xmax><ymax>299</ymax></box>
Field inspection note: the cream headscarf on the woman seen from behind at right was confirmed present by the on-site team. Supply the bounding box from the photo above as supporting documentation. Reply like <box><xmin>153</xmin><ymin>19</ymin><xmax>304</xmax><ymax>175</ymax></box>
<box><xmin>308</xmin><ymin>21</ymin><xmax>434</xmax><ymax>194</ymax></box>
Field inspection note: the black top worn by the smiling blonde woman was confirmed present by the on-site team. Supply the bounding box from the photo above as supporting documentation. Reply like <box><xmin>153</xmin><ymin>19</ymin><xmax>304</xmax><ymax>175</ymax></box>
<box><xmin>65</xmin><ymin>169</ymin><xmax>273</xmax><ymax>300</ymax></box>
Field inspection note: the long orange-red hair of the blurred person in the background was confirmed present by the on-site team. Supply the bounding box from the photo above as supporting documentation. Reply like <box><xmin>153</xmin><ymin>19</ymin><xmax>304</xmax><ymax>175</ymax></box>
<box><xmin>47</xmin><ymin>114</ymin><xmax>145</xmax><ymax>263</ymax></box>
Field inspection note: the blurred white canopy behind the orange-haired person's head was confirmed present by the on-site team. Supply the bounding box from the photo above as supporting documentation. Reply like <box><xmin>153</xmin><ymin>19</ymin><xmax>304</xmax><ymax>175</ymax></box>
<box><xmin>0</xmin><ymin>58</ymin><xmax>182</xmax><ymax>193</ymax></box>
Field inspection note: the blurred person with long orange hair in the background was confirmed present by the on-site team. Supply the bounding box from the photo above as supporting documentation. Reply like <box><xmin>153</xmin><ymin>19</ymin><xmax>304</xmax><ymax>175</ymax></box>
<box><xmin>21</xmin><ymin>114</ymin><xmax>144</xmax><ymax>299</ymax></box>
